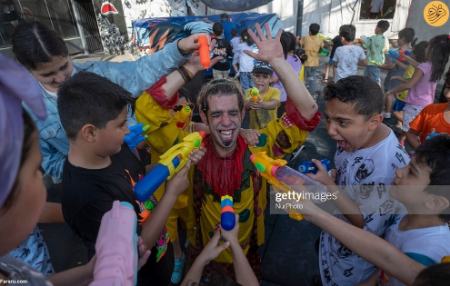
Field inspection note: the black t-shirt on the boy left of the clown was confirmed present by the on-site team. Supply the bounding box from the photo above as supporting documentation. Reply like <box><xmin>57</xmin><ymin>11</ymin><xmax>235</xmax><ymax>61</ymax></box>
<box><xmin>62</xmin><ymin>144</ymin><xmax>145</xmax><ymax>258</ymax></box>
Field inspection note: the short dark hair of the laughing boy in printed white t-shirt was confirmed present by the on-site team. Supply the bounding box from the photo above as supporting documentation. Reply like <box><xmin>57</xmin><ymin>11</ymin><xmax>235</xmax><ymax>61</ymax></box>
<box><xmin>324</xmin><ymin>75</ymin><xmax>384</xmax><ymax>117</ymax></box>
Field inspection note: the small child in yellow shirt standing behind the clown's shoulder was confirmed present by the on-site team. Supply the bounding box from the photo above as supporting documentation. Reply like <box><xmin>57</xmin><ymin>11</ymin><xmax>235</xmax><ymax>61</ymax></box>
<box><xmin>245</xmin><ymin>61</ymin><xmax>280</xmax><ymax>129</ymax></box>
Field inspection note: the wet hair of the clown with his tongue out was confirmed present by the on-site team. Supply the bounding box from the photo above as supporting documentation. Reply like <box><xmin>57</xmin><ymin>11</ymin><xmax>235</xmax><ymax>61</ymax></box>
<box><xmin>197</xmin><ymin>79</ymin><xmax>244</xmax><ymax>113</ymax></box>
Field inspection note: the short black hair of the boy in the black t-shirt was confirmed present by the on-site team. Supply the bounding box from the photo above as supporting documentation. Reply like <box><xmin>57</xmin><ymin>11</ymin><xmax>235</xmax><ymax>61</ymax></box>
<box><xmin>58</xmin><ymin>72</ymin><xmax>134</xmax><ymax>139</ymax></box>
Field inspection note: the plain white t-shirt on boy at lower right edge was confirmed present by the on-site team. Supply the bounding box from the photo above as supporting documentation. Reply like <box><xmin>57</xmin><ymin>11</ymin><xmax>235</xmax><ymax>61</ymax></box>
<box><xmin>385</xmin><ymin>216</ymin><xmax>450</xmax><ymax>286</ymax></box>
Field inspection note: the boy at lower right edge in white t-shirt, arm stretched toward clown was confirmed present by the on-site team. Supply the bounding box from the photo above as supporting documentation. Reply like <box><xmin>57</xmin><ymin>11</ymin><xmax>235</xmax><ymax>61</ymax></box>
<box><xmin>296</xmin><ymin>135</ymin><xmax>450</xmax><ymax>285</ymax></box>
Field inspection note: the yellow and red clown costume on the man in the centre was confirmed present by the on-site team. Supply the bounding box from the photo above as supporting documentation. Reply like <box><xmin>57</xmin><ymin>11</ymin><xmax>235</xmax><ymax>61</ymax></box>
<box><xmin>136</xmin><ymin>77</ymin><xmax>320</xmax><ymax>263</ymax></box>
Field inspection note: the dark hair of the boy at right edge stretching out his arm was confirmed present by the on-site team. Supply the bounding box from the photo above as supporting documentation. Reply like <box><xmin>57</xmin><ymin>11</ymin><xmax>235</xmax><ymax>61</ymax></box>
<box><xmin>415</xmin><ymin>134</ymin><xmax>450</xmax><ymax>221</ymax></box>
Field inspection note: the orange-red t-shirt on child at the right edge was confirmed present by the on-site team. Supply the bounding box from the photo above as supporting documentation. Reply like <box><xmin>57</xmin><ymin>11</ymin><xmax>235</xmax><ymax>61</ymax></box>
<box><xmin>409</xmin><ymin>103</ymin><xmax>450</xmax><ymax>142</ymax></box>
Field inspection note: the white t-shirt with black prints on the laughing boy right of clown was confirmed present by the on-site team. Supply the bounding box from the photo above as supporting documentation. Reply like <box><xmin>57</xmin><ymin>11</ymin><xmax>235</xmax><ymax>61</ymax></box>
<box><xmin>319</xmin><ymin>131</ymin><xmax>410</xmax><ymax>286</ymax></box>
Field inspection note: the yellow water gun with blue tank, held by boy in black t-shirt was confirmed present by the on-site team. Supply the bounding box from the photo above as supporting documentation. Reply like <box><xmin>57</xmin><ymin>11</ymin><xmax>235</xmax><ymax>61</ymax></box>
<box><xmin>134</xmin><ymin>132</ymin><xmax>205</xmax><ymax>202</ymax></box>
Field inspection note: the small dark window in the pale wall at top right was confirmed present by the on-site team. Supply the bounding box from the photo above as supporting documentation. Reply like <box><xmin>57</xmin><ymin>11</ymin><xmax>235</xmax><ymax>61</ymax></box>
<box><xmin>359</xmin><ymin>0</ymin><xmax>397</xmax><ymax>20</ymax></box>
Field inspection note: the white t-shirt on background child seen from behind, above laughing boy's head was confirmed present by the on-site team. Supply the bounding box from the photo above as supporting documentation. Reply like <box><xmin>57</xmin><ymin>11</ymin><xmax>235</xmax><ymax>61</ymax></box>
<box><xmin>333</xmin><ymin>45</ymin><xmax>366</xmax><ymax>81</ymax></box>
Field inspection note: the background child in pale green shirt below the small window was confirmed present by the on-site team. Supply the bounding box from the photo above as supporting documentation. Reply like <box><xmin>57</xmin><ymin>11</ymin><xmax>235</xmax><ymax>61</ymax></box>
<box><xmin>363</xmin><ymin>20</ymin><xmax>389</xmax><ymax>86</ymax></box>
